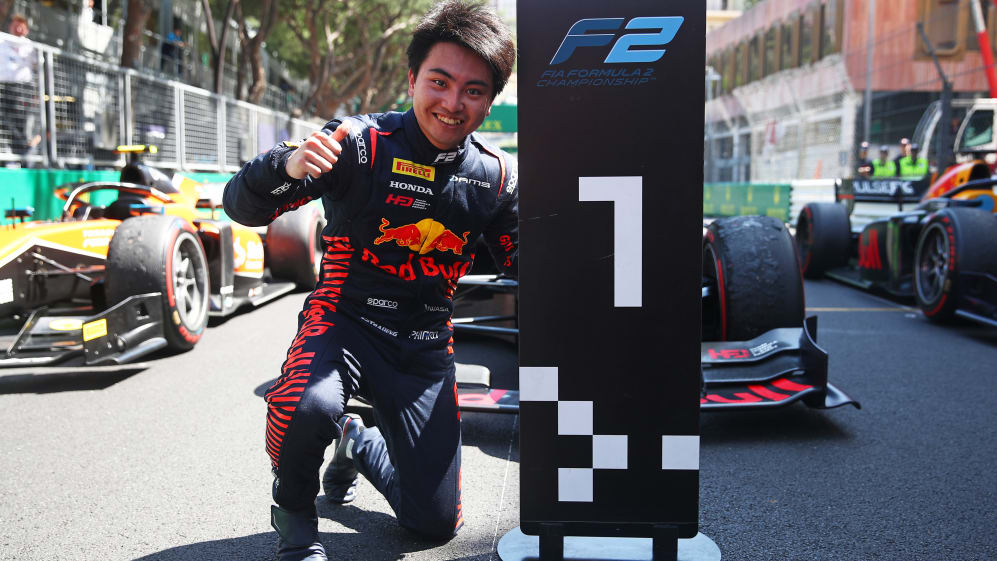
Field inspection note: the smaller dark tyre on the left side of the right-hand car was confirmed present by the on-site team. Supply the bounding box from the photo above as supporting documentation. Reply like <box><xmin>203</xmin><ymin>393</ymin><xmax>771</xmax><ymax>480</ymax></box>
<box><xmin>796</xmin><ymin>203</ymin><xmax>852</xmax><ymax>279</ymax></box>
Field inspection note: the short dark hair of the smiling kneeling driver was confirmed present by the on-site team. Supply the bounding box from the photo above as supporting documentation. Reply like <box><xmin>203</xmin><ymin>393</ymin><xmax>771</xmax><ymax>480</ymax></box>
<box><xmin>406</xmin><ymin>0</ymin><xmax>516</xmax><ymax>98</ymax></box>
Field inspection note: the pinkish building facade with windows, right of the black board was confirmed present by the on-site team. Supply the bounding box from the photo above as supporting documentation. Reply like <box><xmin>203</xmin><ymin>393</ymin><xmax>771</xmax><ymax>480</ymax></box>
<box><xmin>705</xmin><ymin>0</ymin><xmax>997</xmax><ymax>182</ymax></box>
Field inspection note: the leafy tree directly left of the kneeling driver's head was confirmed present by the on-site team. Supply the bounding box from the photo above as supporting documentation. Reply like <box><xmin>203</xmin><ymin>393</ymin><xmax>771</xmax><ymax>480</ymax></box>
<box><xmin>275</xmin><ymin>0</ymin><xmax>430</xmax><ymax>118</ymax></box>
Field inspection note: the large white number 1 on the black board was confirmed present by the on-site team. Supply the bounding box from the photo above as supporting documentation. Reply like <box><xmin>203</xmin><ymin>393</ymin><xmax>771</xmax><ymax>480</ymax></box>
<box><xmin>578</xmin><ymin>176</ymin><xmax>644</xmax><ymax>308</ymax></box>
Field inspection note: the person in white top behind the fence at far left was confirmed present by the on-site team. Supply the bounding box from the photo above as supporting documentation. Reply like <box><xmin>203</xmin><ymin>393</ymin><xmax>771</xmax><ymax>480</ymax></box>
<box><xmin>0</xmin><ymin>14</ymin><xmax>42</xmax><ymax>156</ymax></box>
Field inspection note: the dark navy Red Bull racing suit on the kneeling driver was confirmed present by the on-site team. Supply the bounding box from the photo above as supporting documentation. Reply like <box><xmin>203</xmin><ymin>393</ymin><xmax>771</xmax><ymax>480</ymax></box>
<box><xmin>224</xmin><ymin>111</ymin><xmax>518</xmax><ymax>537</ymax></box>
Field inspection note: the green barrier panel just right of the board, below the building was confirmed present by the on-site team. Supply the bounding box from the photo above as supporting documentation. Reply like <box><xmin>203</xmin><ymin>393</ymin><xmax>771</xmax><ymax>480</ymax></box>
<box><xmin>703</xmin><ymin>183</ymin><xmax>791</xmax><ymax>222</ymax></box>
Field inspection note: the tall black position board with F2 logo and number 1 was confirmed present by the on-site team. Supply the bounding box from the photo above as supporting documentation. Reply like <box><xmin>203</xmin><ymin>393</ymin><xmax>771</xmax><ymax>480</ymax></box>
<box><xmin>517</xmin><ymin>0</ymin><xmax>706</xmax><ymax>538</ymax></box>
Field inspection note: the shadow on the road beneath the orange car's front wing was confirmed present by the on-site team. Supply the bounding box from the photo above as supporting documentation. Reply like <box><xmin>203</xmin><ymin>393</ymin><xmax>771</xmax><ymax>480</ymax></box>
<box><xmin>0</xmin><ymin>364</ymin><xmax>149</xmax><ymax>395</ymax></box>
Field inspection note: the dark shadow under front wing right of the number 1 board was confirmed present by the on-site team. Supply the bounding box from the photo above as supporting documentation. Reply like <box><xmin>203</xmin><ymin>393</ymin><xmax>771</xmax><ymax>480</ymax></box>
<box><xmin>699</xmin><ymin>404</ymin><xmax>854</xmax><ymax>446</ymax></box>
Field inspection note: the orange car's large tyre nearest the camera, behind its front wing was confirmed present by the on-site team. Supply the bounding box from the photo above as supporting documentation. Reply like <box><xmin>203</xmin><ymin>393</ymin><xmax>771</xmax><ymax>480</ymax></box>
<box><xmin>104</xmin><ymin>216</ymin><xmax>210</xmax><ymax>351</ymax></box>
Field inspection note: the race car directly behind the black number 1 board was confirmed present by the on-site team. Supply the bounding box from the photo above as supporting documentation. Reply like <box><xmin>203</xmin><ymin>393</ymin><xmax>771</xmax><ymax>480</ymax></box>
<box><xmin>452</xmin><ymin>216</ymin><xmax>860</xmax><ymax>413</ymax></box>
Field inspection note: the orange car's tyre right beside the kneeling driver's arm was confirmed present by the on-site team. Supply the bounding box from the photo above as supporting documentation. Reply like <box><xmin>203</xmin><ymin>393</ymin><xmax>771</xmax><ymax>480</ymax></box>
<box><xmin>266</xmin><ymin>205</ymin><xmax>325</xmax><ymax>290</ymax></box>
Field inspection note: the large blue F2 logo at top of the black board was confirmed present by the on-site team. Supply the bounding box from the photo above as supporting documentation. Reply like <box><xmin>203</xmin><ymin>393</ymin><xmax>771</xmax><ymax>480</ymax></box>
<box><xmin>550</xmin><ymin>16</ymin><xmax>685</xmax><ymax>64</ymax></box>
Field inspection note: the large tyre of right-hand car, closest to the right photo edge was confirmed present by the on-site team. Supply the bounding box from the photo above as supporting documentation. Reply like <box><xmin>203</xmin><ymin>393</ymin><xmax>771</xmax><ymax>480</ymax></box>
<box><xmin>914</xmin><ymin>208</ymin><xmax>997</xmax><ymax>322</ymax></box>
